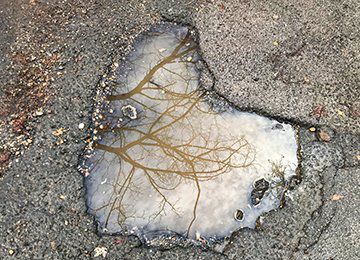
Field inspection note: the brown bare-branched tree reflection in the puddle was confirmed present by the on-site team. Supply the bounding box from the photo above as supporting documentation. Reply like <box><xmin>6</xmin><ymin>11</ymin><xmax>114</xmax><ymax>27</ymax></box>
<box><xmin>90</xmin><ymin>29</ymin><xmax>254</xmax><ymax>235</ymax></box>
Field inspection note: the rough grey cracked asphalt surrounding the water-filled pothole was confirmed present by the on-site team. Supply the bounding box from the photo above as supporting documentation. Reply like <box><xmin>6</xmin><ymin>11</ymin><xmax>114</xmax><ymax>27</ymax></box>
<box><xmin>0</xmin><ymin>0</ymin><xmax>360</xmax><ymax>259</ymax></box>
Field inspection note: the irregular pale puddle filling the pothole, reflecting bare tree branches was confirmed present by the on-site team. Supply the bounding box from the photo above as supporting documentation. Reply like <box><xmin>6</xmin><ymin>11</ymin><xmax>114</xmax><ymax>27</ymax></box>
<box><xmin>81</xmin><ymin>24</ymin><xmax>298</xmax><ymax>243</ymax></box>
